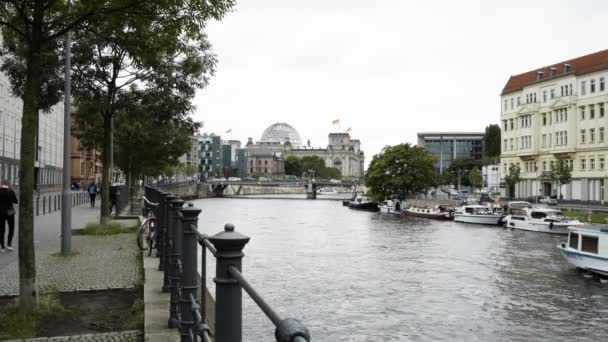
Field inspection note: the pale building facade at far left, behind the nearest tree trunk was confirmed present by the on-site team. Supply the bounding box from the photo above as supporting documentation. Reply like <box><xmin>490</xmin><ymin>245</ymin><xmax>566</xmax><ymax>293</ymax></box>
<box><xmin>0</xmin><ymin>66</ymin><xmax>64</xmax><ymax>189</ymax></box>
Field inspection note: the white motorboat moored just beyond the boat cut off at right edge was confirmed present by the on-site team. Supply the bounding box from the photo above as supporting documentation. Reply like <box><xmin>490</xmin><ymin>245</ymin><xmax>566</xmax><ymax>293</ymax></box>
<box><xmin>503</xmin><ymin>202</ymin><xmax>583</xmax><ymax>234</ymax></box>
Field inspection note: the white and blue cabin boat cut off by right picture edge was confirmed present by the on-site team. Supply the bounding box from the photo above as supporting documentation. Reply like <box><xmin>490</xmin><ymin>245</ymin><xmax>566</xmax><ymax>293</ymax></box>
<box><xmin>557</xmin><ymin>225</ymin><xmax>608</xmax><ymax>276</ymax></box>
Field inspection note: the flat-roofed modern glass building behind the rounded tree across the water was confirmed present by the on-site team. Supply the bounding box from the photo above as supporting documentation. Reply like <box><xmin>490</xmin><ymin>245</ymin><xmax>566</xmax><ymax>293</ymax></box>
<box><xmin>418</xmin><ymin>132</ymin><xmax>484</xmax><ymax>173</ymax></box>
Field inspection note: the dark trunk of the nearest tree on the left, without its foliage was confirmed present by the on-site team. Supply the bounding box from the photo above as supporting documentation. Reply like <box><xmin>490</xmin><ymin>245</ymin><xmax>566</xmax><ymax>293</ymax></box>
<box><xmin>18</xmin><ymin>23</ymin><xmax>43</xmax><ymax>314</ymax></box>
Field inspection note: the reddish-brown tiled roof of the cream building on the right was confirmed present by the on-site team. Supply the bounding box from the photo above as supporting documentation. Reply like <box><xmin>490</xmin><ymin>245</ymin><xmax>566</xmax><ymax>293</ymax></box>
<box><xmin>500</xmin><ymin>50</ymin><xmax>608</xmax><ymax>95</ymax></box>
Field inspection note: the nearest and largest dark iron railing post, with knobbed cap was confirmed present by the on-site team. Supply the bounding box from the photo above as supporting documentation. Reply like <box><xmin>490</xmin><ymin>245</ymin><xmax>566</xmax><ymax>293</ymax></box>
<box><xmin>209</xmin><ymin>224</ymin><xmax>249</xmax><ymax>342</ymax></box>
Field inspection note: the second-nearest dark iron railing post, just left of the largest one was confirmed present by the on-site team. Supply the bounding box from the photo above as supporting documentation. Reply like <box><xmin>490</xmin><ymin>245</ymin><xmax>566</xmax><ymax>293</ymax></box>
<box><xmin>179</xmin><ymin>206</ymin><xmax>205</xmax><ymax>342</ymax></box>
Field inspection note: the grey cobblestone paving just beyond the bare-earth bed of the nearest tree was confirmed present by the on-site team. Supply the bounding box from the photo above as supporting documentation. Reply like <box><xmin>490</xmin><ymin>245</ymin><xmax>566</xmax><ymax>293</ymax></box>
<box><xmin>0</xmin><ymin>233</ymin><xmax>141</xmax><ymax>295</ymax></box>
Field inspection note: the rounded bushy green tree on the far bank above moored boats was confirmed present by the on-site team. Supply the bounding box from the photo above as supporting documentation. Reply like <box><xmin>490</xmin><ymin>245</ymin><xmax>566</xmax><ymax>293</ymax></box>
<box><xmin>365</xmin><ymin>144</ymin><xmax>437</xmax><ymax>198</ymax></box>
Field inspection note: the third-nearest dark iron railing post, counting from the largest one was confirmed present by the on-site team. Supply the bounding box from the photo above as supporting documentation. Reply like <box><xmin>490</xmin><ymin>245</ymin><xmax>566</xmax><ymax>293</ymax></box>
<box><xmin>165</xmin><ymin>198</ymin><xmax>184</xmax><ymax>329</ymax></box>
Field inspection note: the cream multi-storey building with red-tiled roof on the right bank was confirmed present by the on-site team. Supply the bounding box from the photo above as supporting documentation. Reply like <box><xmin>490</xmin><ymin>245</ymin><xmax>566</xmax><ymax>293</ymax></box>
<box><xmin>501</xmin><ymin>50</ymin><xmax>608</xmax><ymax>201</ymax></box>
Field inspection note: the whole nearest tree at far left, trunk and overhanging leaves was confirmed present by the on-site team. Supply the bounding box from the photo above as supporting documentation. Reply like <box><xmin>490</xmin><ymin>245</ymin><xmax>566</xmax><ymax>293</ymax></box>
<box><xmin>0</xmin><ymin>0</ymin><xmax>163</xmax><ymax>313</ymax></box>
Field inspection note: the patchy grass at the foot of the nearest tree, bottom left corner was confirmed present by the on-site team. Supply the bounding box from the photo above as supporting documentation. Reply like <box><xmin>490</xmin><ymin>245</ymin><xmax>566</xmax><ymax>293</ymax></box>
<box><xmin>0</xmin><ymin>294</ymin><xmax>72</xmax><ymax>340</ymax></box>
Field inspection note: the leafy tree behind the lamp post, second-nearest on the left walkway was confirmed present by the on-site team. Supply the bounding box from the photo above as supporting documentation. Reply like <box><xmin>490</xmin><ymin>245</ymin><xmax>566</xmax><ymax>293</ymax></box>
<box><xmin>74</xmin><ymin>0</ymin><xmax>233</xmax><ymax>224</ymax></box>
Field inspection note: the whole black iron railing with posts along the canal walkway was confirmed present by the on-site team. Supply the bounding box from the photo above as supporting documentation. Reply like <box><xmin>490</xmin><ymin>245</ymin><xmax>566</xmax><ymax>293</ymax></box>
<box><xmin>145</xmin><ymin>187</ymin><xmax>310</xmax><ymax>342</ymax></box>
